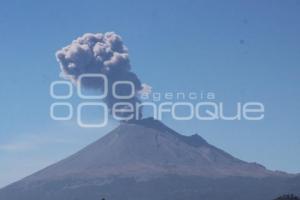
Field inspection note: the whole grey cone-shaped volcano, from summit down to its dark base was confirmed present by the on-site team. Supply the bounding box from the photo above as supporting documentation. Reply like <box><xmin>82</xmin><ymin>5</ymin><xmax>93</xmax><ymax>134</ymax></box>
<box><xmin>0</xmin><ymin>118</ymin><xmax>300</xmax><ymax>200</ymax></box>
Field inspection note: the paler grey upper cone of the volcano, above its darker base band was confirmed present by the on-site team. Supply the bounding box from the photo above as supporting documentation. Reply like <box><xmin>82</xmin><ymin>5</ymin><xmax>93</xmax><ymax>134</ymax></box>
<box><xmin>7</xmin><ymin>118</ymin><xmax>286</xmax><ymax>184</ymax></box>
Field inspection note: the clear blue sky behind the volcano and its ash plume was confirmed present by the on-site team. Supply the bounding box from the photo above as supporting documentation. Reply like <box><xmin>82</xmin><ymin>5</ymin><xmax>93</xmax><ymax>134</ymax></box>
<box><xmin>0</xmin><ymin>0</ymin><xmax>300</xmax><ymax>187</ymax></box>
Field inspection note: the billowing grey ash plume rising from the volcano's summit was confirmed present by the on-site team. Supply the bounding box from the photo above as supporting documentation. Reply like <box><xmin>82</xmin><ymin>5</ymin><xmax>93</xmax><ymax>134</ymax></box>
<box><xmin>56</xmin><ymin>32</ymin><xmax>143</xmax><ymax>120</ymax></box>
